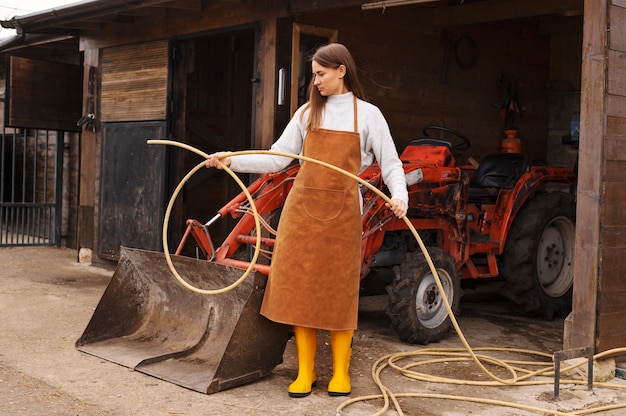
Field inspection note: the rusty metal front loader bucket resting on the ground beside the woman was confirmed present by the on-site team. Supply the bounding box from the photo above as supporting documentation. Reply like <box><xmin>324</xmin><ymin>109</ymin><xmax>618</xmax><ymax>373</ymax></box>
<box><xmin>76</xmin><ymin>247</ymin><xmax>289</xmax><ymax>393</ymax></box>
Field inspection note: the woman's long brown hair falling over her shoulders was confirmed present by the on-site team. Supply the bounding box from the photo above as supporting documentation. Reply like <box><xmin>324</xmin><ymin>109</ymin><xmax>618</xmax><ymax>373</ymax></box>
<box><xmin>300</xmin><ymin>43</ymin><xmax>367</xmax><ymax>131</ymax></box>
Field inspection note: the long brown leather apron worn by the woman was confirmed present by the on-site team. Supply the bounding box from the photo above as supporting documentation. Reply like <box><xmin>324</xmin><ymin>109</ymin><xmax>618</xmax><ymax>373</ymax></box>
<box><xmin>261</xmin><ymin>98</ymin><xmax>362</xmax><ymax>331</ymax></box>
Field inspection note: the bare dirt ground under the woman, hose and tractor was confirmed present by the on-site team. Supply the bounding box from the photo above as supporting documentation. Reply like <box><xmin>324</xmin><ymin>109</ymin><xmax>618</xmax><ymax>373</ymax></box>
<box><xmin>0</xmin><ymin>247</ymin><xmax>626</xmax><ymax>416</ymax></box>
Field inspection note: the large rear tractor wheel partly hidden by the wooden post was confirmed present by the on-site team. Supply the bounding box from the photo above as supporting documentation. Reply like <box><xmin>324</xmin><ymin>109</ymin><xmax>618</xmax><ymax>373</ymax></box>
<box><xmin>501</xmin><ymin>192</ymin><xmax>576</xmax><ymax>319</ymax></box>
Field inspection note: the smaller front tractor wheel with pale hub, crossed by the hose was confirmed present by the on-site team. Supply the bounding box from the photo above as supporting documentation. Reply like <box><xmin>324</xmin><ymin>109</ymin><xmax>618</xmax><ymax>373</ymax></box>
<box><xmin>386</xmin><ymin>248</ymin><xmax>461</xmax><ymax>344</ymax></box>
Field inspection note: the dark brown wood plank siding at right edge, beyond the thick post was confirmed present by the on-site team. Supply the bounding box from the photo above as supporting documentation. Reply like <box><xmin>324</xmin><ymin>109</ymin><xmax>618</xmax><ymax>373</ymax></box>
<box><xmin>592</xmin><ymin>1</ymin><xmax>626</xmax><ymax>351</ymax></box>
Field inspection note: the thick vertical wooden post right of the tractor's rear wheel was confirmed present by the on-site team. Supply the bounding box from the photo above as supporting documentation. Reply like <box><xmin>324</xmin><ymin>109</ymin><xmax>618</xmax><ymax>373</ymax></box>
<box><xmin>565</xmin><ymin>0</ymin><xmax>610</xmax><ymax>348</ymax></box>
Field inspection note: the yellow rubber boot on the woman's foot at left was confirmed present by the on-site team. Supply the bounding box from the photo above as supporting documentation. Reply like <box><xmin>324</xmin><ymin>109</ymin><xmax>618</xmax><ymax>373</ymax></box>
<box><xmin>288</xmin><ymin>326</ymin><xmax>317</xmax><ymax>397</ymax></box>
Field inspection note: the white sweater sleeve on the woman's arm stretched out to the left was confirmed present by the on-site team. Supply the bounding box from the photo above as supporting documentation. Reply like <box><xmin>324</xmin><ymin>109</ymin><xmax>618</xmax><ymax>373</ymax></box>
<box><xmin>230</xmin><ymin>111</ymin><xmax>305</xmax><ymax>173</ymax></box>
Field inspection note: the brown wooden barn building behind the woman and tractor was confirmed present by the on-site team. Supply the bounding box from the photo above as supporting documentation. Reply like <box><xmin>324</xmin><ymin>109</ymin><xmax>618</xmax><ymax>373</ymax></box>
<box><xmin>0</xmin><ymin>0</ymin><xmax>626</xmax><ymax>352</ymax></box>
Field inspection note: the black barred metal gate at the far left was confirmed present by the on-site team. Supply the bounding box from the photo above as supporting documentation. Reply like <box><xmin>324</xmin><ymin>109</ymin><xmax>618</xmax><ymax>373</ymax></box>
<box><xmin>0</xmin><ymin>128</ymin><xmax>64</xmax><ymax>247</ymax></box>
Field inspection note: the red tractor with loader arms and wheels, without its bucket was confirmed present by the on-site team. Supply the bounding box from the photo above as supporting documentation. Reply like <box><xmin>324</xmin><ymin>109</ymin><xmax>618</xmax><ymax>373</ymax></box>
<box><xmin>177</xmin><ymin>126</ymin><xmax>576</xmax><ymax>344</ymax></box>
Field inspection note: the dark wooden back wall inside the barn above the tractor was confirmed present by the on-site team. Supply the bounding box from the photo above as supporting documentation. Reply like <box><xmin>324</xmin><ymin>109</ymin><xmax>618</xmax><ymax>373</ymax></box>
<box><xmin>298</xmin><ymin>6</ymin><xmax>582</xmax><ymax>167</ymax></box>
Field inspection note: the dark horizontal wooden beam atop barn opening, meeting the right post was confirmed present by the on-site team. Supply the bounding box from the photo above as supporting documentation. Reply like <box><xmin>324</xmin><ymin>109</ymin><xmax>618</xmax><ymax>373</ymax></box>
<box><xmin>433</xmin><ymin>0</ymin><xmax>583</xmax><ymax>27</ymax></box>
